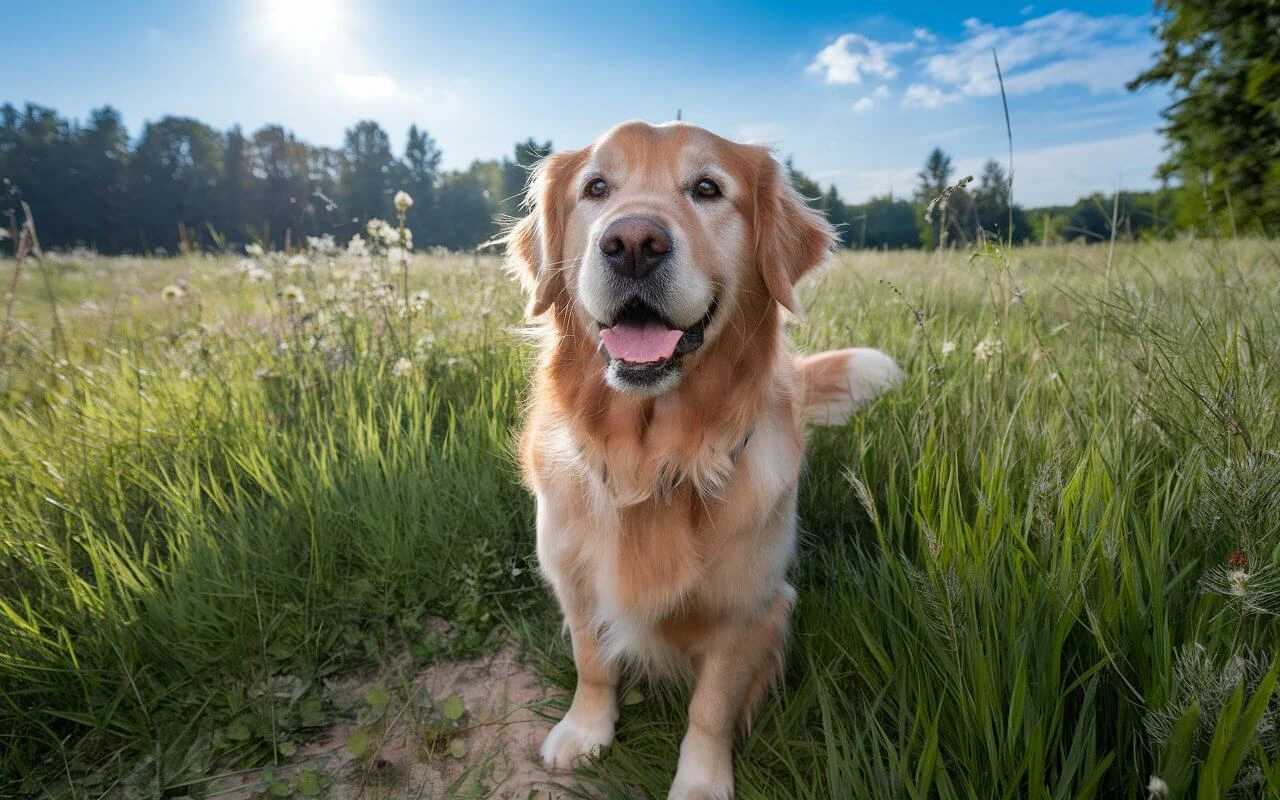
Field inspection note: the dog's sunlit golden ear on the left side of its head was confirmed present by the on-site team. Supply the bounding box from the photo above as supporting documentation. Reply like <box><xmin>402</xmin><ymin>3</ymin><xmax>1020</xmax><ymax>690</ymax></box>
<box><xmin>506</xmin><ymin>150</ymin><xmax>586</xmax><ymax>317</ymax></box>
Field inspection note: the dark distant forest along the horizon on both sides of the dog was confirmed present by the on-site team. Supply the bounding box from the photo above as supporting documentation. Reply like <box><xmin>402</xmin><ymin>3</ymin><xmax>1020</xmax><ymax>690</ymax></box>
<box><xmin>0</xmin><ymin>104</ymin><xmax>1176</xmax><ymax>253</ymax></box>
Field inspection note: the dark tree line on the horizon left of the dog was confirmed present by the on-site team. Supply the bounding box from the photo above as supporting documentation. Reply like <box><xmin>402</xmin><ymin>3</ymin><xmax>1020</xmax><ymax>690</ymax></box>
<box><xmin>0</xmin><ymin>104</ymin><xmax>552</xmax><ymax>253</ymax></box>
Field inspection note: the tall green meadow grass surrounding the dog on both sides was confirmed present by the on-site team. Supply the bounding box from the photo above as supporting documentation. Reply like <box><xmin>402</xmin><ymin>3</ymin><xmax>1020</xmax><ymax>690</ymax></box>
<box><xmin>0</xmin><ymin>235</ymin><xmax>1280</xmax><ymax>799</ymax></box>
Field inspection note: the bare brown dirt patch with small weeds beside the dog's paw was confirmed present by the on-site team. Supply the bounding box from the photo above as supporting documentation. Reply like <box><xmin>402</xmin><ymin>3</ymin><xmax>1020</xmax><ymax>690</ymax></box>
<box><xmin>207</xmin><ymin>643</ymin><xmax>572</xmax><ymax>800</ymax></box>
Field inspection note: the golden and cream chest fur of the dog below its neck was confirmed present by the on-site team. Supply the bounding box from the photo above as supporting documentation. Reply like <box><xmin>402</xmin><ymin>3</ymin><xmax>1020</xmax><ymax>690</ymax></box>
<box><xmin>526</xmin><ymin>396</ymin><xmax>803</xmax><ymax>667</ymax></box>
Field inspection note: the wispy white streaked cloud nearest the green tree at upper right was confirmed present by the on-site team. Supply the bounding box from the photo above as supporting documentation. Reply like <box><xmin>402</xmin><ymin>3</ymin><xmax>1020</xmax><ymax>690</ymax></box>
<box><xmin>922</xmin><ymin>10</ymin><xmax>1153</xmax><ymax>100</ymax></box>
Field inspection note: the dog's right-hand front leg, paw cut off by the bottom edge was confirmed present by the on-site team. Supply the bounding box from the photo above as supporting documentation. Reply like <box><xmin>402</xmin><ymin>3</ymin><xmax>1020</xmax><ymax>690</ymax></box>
<box><xmin>667</xmin><ymin>586</ymin><xmax>795</xmax><ymax>800</ymax></box>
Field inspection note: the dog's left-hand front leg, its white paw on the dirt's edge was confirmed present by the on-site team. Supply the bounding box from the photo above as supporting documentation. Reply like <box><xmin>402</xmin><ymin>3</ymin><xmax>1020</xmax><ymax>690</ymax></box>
<box><xmin>541</xmin><ymin>602</ymin><xmax>618</xmax><ymax>769</ymax></box>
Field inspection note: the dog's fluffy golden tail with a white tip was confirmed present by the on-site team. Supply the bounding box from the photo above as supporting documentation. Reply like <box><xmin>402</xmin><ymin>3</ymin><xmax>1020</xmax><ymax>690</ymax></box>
<box><xmin>795</xmin><ymin>347</ymin><xmax>902</xmax><ymax>425</ymax></box>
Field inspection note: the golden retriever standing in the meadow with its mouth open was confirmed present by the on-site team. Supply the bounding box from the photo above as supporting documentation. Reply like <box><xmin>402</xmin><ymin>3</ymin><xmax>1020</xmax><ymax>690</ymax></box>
<box><xmin>506</xmin><ymin>122</ymin><xmax>901</xmax><ymax>800</ymax></box>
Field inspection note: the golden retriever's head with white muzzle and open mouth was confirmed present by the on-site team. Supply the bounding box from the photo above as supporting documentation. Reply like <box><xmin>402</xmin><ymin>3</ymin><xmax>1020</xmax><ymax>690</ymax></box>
<box><xmin>507</xmin><ymin>122</ymin><xmax>833</xmax><ymax>397</ymax></box>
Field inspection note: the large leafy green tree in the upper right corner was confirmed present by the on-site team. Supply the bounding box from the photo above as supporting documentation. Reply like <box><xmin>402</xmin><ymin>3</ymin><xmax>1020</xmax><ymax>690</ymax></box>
<box><xmin>1129</xmin><ymin>0</ymin><xmax>1280</xmax><ymax>233</ymax></box>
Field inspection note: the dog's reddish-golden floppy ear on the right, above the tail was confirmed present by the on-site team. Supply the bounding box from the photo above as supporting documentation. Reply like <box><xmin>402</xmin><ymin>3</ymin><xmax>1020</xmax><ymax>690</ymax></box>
<box><xmin>755</xmin><ymin>151</ymin><xmax>836</xmax><ymax>314</ymax></box>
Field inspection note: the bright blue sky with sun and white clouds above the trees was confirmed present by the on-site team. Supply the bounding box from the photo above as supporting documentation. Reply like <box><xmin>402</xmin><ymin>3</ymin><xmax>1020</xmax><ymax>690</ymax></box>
<box><xmin>0</xmin><ymin>0</ymin><xmax>1169</xmax><ymax>206</ymax></box>
